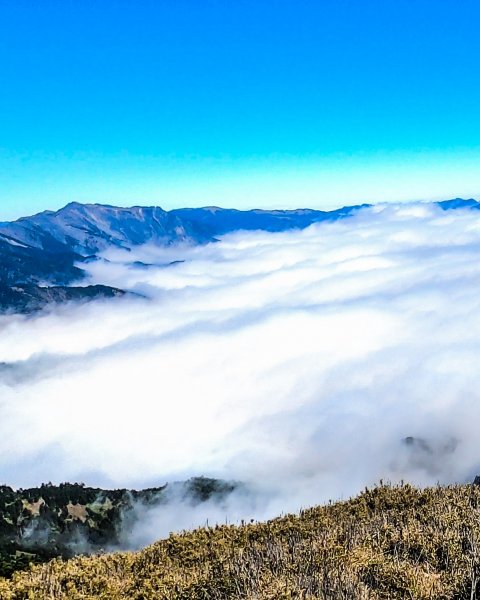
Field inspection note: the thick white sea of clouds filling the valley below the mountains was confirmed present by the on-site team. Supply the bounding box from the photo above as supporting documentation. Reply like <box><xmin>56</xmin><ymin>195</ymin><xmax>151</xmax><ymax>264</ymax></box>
<box><xmin>0</xmin><ymin>204</ymin><xmax>480</xmax><ymax>544</ymax></box>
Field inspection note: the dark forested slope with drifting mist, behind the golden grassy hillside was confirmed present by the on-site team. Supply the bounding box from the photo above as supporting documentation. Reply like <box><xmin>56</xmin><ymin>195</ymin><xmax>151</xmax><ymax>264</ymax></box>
<box><xmin>0</xmin><ymin>477</ymin><xmax>238</xmax><ymax>576</ymax></box>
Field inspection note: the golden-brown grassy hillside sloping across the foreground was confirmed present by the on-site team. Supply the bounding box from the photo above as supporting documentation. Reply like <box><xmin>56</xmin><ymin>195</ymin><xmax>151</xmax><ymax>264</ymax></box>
<box><xmin>0</xmin><ymin>485</ymin><xmax>480</xmax><ymax>600</ymax></box>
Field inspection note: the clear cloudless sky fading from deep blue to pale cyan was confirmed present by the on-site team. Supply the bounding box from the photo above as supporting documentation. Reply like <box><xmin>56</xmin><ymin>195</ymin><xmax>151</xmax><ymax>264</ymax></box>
<box><xmin>0</xmin><ymin>0</ymin><xmax>480</xmax><ymax>219</ymax></box>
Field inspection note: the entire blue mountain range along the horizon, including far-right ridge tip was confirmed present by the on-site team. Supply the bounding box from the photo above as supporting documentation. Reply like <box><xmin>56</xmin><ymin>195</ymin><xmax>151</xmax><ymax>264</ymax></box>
<box><xmin>0</xmin><ymin>198</ymin><xmax>480</xmax><ymax>313</ymax></box>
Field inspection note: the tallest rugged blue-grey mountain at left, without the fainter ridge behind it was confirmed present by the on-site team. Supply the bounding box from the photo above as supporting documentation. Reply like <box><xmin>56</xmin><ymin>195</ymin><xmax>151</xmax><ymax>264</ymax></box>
<box><xmin>0</xmin><ymin>202</ymin><xmax>214</xmax><ymax>313</ymax></box>
